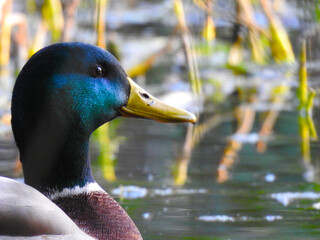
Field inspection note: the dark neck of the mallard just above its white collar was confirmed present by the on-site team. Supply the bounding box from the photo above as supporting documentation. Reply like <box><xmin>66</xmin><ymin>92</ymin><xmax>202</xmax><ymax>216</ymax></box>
<box><xmin>20</xmin><ymin>119</ymin><xmax>94</xmax><ymax>195</ymax></box>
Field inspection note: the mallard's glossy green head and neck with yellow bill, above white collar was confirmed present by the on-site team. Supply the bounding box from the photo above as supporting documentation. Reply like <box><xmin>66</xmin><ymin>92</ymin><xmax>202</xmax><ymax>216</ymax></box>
<box><xmin>12</xmin><ymin>43</ymin><xmax>196</xmax><ymax>193</ymax></box>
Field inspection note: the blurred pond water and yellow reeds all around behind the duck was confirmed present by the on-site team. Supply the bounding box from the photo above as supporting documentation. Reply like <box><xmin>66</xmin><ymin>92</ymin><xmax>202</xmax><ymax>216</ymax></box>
<box><xmin>0</xmin><ymin>0</ymin><xmax>320</xmax><ymax>240</ymax></box>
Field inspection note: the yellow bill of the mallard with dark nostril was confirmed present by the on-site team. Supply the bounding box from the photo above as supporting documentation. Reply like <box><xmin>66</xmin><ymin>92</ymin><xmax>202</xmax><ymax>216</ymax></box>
<box><xmin>120</xmin><ymin>78</ymin><xmax>197</xmax><ymax>123</ymax></box>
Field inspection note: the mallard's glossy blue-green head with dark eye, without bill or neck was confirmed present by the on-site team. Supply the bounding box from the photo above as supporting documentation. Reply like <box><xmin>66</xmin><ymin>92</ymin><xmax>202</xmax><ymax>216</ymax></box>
<box><xmin>12</xmin><ymin>43</ymin><xmax>130</xmax><ymax>151</ymax></box>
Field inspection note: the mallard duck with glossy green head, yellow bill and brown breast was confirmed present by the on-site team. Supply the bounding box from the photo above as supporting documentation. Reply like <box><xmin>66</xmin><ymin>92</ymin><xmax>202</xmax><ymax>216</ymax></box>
<box><xmin>0</xmin><ymin>43</ymin><xmax>196</xmax><ymax>240</ymax></box>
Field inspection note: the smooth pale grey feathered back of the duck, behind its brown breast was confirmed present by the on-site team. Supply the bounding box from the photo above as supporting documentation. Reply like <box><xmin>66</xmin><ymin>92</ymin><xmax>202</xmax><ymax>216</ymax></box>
<box><xmin>0</xmin><ymin>177</ymin><xmax>93</xmax><ymax>240</ymax></box>
